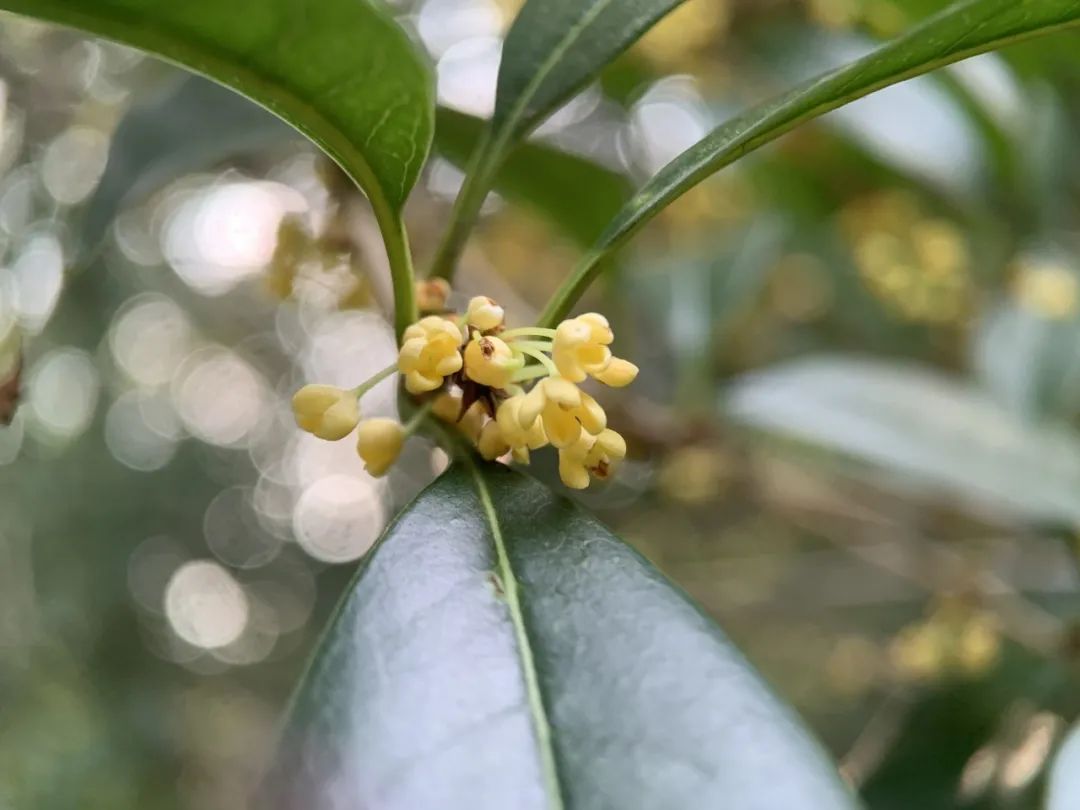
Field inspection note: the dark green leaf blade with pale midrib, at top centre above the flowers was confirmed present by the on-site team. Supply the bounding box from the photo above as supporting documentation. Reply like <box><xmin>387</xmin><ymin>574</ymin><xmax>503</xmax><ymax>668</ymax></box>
<box><xmin>491</xmin><ymin>0</ymin><xmax>684</xmax><ymax>143</ymax></box>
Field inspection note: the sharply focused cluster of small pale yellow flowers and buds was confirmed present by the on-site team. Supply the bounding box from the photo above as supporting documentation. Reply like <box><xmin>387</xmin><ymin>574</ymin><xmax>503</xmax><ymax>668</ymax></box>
<box><xmin>293</xmin><ymin>283</ymin><xmax>637</xmax><ymax>489</ymax></box>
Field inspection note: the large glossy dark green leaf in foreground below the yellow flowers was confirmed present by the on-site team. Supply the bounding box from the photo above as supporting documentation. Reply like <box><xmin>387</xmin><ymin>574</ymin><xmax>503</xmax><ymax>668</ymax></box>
<box><xmin>266</xmin><ymin>465</ymin><xmax>854</xmax><ymax>810</ymax></box>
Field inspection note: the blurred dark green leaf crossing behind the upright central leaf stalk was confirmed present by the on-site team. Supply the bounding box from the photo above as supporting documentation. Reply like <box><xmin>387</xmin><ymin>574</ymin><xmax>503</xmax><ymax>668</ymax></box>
<box><xmin>435</xmin><ymin>108</ymin><xmax>631</xmax><ymax>246</ymax></box>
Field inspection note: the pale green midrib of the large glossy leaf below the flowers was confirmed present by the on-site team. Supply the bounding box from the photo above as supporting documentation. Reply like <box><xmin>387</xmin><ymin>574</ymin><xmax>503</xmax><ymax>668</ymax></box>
<box><xmin>465</xmin><ymin>458</ymin><xmax>564</xmax><ymax>810</ymax></box>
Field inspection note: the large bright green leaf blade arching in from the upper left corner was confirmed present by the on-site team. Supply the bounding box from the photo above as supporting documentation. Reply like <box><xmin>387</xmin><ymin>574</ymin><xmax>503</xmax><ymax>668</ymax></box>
<box><xmin>0</xmin><ymin>0</ymin><xmax>434</xmax><ymax>225</ymax></box>
